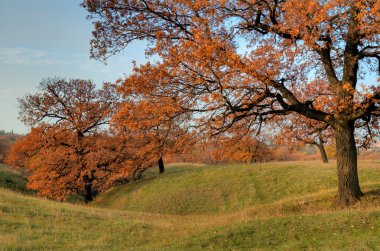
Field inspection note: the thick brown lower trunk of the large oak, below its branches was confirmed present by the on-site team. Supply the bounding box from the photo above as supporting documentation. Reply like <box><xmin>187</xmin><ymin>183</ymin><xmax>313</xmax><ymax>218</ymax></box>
<box><xmin>335</xmin><ymin>122</ymin><xmax>363</xmax><ymax>207</ymax></box>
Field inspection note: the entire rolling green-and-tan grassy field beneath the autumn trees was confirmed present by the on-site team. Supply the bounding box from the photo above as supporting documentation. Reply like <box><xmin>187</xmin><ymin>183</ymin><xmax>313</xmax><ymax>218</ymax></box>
<box><xmin>0</xmin><ymin>161</ymin><xmax>380</xmax><ymax>250</ymax></box>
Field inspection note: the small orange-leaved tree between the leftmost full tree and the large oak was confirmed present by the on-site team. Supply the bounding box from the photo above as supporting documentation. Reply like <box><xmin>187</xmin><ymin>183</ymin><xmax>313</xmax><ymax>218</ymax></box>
<box><xmin>113</xmin><ymin>81</ymin><xmax>195</xmax><ymax>174</ymax></box>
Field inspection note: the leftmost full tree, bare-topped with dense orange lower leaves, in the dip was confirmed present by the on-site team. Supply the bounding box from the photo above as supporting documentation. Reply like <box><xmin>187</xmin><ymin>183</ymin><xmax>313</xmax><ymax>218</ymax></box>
<box><xmin>8</xmin><ymin>78</ymin><xmax>139</xmax><ymax>201</ymax></box>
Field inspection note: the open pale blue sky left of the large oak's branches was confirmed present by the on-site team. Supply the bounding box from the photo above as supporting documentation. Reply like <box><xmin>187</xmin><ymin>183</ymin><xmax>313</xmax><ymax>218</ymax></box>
<box><xmin>0</xmin><ymin>0</ymin><xmax>146</xmax><ymax>134</ymax></box>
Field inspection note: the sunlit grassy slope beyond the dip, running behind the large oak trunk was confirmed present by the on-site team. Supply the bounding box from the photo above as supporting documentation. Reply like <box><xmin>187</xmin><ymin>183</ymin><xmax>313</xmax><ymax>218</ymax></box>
<box><xmin>94</xmin><ymin>161</ymin><xmax>380</xmax><ymax>215</ymax></box>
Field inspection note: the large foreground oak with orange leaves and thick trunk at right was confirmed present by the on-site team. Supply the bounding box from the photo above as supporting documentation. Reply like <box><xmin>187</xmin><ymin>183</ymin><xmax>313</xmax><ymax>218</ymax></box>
<box><xmin>83</xmin><ymin>0</ymin><xmax>380</xmax><ymax>206</ymax></box>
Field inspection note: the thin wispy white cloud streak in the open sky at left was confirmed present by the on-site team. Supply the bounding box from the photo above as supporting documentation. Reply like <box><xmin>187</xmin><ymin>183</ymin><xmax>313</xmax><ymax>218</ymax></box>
<box><xmin>0</xmin><ymin>47</ymin><xmax>79</xmax><ymax>65</ymax></box>
